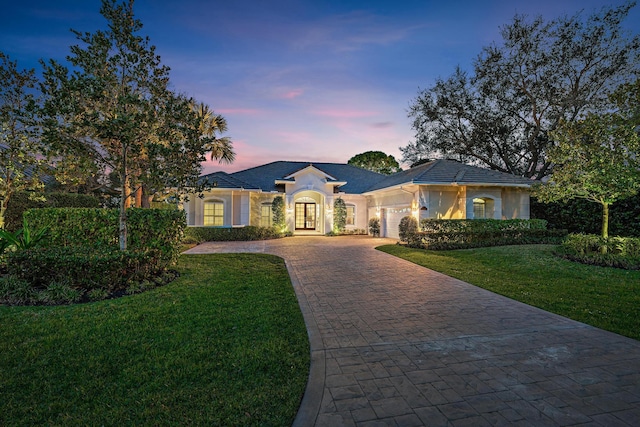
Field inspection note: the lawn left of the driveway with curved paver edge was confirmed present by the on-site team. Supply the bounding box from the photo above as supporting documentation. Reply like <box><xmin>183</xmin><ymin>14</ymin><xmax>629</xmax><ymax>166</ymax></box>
<box><xmin>0</xmin><ymin>254</ymin><xmax>309</xmax><ymax>426</ymax></box>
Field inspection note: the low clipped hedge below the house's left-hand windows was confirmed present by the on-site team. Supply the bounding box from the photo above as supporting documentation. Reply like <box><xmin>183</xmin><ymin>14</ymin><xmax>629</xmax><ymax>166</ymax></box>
<box><xmin>183</xmin><ymin>225</ymin><xmax>285</xmax><ymax>244</ymax></box>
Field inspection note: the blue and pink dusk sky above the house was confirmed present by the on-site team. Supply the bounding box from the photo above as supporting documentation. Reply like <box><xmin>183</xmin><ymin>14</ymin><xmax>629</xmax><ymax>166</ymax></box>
<box><xmin>0</xmin><ymin>0</ymin><xmax>640</xmax><ymax>173</ymax></box>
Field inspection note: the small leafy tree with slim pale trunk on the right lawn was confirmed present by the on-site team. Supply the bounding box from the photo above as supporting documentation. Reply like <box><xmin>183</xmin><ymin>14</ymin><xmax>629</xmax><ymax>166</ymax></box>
<box><xmin>535</xmin><ymin>80</ymin><xmax>640</xmax><ymax>238</ymax></box>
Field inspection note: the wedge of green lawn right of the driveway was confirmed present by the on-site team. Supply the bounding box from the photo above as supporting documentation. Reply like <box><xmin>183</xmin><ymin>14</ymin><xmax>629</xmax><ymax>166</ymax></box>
<box><xmin>378</xmin><ymin>245</ymin><xmax>640</xmax><ymax>340</ymax></box>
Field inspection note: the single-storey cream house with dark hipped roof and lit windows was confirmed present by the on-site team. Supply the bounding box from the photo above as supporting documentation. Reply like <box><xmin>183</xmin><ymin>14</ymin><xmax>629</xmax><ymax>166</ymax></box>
<box><xmin>183</xmin><ymin>160</ymin><xmax>532</xmax><ymax>238</ymax></box>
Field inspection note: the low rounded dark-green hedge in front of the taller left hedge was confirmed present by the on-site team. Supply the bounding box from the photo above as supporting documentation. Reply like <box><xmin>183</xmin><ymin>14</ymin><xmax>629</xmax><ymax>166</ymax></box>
<box><xmin>7</xmin><ymin>246</ymin><xmax>158</xmax><ymax>292</ymax></box>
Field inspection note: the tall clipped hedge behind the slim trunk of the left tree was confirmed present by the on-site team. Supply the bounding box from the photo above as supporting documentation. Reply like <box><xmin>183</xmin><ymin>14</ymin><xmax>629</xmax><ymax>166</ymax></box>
<box><xmin>24</xmin><ymin>208</ymin><xmax>186</xmax><ymax>270</ymax></box>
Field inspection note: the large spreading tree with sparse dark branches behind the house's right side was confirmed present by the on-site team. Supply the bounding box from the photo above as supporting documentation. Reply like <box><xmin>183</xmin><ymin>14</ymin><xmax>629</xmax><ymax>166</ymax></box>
<box><xmin>401</xmin><ymin>3</ymin><xmax>640</xmax><ymax>179</ymax></box>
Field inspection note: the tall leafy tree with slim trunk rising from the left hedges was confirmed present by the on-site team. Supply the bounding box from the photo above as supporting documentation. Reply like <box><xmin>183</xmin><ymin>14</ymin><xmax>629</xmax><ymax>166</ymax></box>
<box><xmin>42</xmin><ymin>0</ymin><xmax>218</xmax><ymax>250</ymax></box>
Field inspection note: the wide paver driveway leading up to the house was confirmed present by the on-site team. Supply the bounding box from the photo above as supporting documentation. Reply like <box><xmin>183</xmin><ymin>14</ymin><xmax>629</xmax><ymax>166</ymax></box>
<box><xmin>189</xmin><ymin>237</ymin><xmax>640</xmax><ymax>426</ymax></box>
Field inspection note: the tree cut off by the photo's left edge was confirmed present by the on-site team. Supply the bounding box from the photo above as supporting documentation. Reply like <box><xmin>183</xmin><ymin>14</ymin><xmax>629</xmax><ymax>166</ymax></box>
<box><xmin>0</xmin><ymin>52</ymin><xmax>43</xmax><ymax>227</ymax></box>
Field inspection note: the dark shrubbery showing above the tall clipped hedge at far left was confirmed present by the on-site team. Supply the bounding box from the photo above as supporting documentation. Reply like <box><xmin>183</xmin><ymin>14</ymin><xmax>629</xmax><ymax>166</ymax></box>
<box><xmin>5</xmin><ymin>192</ymin><xmax>100</xmax><ymax>231</ymax></box>
